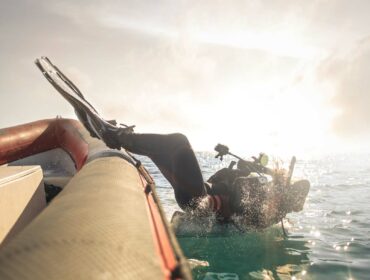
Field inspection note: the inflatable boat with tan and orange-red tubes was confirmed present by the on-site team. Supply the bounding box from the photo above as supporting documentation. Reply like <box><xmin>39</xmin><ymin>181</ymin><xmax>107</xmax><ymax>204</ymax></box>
<box><xmin>0</xmin><ymin>118</ymin><xmax>191</xmax><ymax>279</ymax></box>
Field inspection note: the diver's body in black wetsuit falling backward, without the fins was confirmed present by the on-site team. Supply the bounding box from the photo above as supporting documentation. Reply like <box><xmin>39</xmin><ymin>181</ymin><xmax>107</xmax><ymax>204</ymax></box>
<box><xmin>98</xmin><ymin>127</ymin><xmax>309</xmax><ymax>225</ymax></box>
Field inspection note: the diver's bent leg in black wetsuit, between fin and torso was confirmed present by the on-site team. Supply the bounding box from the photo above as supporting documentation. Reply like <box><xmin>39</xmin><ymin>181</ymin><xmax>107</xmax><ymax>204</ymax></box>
<box><xmin>120</xmin><ymin>133</ymin><xmax>206</xmax><ymax>208</ymax></box>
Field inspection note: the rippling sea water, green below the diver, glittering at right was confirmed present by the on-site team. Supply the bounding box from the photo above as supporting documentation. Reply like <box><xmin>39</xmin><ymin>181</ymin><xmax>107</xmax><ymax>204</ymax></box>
<box><xmin>141</xmin><ymin>153</ymin><xmax>370</xmax><ymax>280</ymax></box>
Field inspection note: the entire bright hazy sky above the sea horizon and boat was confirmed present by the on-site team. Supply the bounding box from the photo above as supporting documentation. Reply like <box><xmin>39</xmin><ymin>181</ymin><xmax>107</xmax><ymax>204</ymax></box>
<box><xmin>0</xmin><ymin>0</ymin><xmax>370</xmax><ymax>156</ymax></box>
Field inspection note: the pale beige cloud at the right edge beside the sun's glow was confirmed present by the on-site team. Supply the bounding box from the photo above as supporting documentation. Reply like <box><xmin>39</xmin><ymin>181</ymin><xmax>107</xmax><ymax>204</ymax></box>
<box><xmin>319</xmin><ymin>37</ymin><xmax>370</xmax><ymax>138</ymax></box>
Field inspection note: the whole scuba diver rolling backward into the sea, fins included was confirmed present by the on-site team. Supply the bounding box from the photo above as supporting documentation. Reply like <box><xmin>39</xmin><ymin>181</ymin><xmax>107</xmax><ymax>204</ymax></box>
<box><xmin>35</xmin><ymin>57</ymin><xmax>310</xmax><ymax>228</ymax></box>
